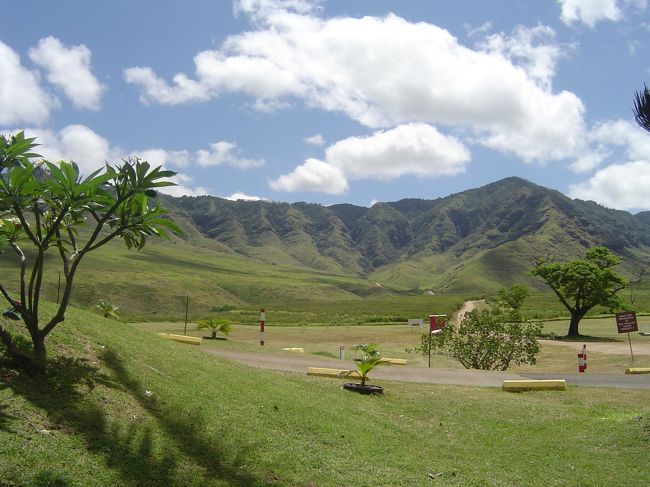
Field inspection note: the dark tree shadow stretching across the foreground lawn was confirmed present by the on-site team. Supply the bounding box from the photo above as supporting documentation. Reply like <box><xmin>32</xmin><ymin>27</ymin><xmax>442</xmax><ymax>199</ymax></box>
<box><xmin>8</xmin><ymin>352</ymin><xmax>263</xmax><ymax>487</ymax></box>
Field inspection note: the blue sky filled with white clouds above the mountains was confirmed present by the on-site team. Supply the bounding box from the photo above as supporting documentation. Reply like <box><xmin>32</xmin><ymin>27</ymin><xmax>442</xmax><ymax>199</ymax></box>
<box><xmin>0</xmin><ymin>0</ymin><xmax>650</xmax><ymax>213</ymax></box>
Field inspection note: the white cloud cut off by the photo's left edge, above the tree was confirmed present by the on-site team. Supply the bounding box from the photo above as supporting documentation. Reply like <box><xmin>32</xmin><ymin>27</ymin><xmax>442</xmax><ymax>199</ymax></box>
<box><xmin>0</xmin><ymin>42</ymin><xmax>58</xmax><ymax>126</ymax></box>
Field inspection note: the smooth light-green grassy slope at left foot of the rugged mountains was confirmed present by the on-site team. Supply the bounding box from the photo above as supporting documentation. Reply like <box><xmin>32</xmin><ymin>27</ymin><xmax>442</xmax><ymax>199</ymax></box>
<box><xmin>0</xmin><ymin>241</ymin><xmax>400</xmax><ymax>319</ymax></box>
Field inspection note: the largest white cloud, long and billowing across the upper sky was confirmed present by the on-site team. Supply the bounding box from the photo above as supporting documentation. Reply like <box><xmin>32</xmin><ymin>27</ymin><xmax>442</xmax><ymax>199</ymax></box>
<box><xmin>125</xmin><ymin>10</ymin><xmax>584</xmax><ymax>161</ymax></box>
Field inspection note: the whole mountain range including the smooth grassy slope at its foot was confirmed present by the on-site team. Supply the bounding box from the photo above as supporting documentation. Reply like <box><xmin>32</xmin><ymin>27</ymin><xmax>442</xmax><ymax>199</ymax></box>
<box><xmin>0</xmin><ymin>178</ymin><xmax>650</xmax><ymax>323</ymax></box>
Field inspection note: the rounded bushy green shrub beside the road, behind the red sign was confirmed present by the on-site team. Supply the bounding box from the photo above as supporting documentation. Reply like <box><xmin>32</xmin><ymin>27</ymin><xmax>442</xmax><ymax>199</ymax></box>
<box><xmin>422</xmin><ymin>308</ymin><xmax>541</xmax><ymax>370</ymax></box>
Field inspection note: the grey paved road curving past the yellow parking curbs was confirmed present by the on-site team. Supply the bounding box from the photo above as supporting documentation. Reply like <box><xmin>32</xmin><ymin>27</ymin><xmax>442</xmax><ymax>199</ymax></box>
<box><xmin>204</xmin><ymin>349</ymin><xmax>650</xmax><ymax>389</ymax></box>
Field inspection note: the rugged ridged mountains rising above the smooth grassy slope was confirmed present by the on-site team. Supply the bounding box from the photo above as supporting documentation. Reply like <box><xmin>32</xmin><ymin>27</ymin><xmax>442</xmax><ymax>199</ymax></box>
<box><xmin>163</xmin><ymin>177</ymin><xmax>650</xmax><ymax>293</ymax></box>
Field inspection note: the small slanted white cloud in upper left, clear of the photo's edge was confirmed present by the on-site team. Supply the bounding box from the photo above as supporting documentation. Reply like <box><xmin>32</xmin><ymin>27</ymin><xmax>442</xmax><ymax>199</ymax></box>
<box><xmin>29</xmin><ymin>36</ymin><xmax>104</xmax><ymax>110</ymax></box>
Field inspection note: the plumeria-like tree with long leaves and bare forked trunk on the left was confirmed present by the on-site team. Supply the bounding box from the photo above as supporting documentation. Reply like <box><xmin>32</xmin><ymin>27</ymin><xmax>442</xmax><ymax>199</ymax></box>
<box><xmin>0</xmin><ymin>132</ymin><xmax>181</xmax><ymax>369</ymax></box>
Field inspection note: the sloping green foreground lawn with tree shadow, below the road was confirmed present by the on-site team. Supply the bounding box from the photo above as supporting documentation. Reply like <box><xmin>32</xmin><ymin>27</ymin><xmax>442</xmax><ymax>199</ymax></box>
<box><xmin>0</xmin><ymin>304</ymin><xmax>650</xmax><ymax>486</ymax></box>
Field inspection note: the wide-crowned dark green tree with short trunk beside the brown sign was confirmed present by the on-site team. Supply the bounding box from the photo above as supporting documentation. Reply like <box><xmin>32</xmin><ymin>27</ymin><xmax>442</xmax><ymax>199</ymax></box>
<box><xmin>532</xmin><ymin>247</ymin><xmax>627</xmax><ymax>337</ymax></box>
